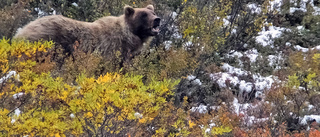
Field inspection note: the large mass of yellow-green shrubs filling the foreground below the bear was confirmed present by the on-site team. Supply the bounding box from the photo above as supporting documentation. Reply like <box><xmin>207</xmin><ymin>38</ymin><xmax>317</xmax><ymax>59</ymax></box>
<box><xmin>0</xmin><ymin>39</ymin><xmax>245</xmax><ymax>136</ymax></box>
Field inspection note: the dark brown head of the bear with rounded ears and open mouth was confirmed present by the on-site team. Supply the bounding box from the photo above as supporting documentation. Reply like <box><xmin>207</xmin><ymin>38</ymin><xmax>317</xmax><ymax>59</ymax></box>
<box><xmin>124</xmin><ymin>5</ymin><xmax>161</xmax><ymax>39</ymax></box>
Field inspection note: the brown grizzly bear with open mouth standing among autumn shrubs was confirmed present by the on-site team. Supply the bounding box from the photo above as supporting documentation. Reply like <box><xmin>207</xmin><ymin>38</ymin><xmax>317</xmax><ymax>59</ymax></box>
<box><xmin>15</xmin><ymin>5</ymin><xmax>160</xmax><ymax>60</ymax></box>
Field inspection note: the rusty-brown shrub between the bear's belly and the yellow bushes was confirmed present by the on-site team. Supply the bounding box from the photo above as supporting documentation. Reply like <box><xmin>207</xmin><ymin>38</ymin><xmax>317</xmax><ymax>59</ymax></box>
<box><xmin>56</xmin><ymin>44</ymin><xmax>121</xmax><ymax>83</ymax></box>
